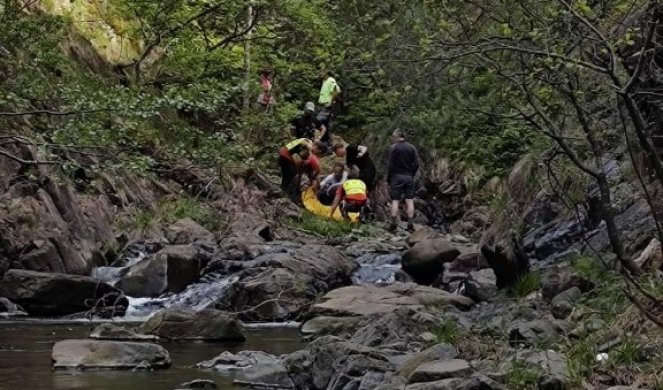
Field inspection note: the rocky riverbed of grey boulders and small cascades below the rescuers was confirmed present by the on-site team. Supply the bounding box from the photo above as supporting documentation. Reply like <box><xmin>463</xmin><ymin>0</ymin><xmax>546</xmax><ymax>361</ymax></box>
<box><xmin>0</xmin><ymin>154</ymin><xmax>663</xmax><ymax>390</ymax></box>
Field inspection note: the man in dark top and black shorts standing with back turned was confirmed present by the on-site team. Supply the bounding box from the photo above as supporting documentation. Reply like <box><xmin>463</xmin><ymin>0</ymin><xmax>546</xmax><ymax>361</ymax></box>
<box><xmin>387</xmin><ymin>129</ymin><xmax>419</xmax><ymax>230</ymax></box>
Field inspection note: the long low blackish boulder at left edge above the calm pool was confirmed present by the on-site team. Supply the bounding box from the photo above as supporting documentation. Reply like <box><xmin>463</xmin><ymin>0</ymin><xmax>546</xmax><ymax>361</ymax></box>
<box><xmin>0</xmin><ymin>269</ymin><xmax>129</xmax><ymax>317</ymax></box>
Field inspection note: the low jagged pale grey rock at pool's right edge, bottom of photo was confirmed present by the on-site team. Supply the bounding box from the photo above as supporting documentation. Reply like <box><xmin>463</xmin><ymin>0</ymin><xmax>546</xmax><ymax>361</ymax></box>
<box><xmin>196</xmin><ymin>351</ymin><xmax>295</xmax><ymax>389</ymax></box>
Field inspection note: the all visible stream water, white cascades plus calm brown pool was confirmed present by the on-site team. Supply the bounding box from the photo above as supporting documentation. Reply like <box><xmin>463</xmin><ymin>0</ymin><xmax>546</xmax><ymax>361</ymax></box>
<box><xmin>0</xmin><ymin>248</ymin><xmax>403</xmax><ymax>390</ymax></box>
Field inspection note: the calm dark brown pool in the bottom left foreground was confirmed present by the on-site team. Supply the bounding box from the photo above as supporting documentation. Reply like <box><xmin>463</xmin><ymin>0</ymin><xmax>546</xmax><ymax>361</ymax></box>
<box><xmin>0</xmin><ymin>321</ymin><xmax>304</xmax><ymax>390</ymax></box>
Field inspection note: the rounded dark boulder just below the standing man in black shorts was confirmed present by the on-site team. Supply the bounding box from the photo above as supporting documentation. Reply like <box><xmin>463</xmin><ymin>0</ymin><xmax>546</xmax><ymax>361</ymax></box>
<box><xmin>402</xmin><ymin>237</ymin><xmax>460</xmax><ymax>285</ymax></box>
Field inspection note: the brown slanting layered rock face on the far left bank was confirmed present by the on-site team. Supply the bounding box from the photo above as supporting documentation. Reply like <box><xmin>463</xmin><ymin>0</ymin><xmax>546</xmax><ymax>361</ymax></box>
<box><xmin>0</xmin><ymin>174</ymin><xmax>115</xmax><ymax>275</ymax></box>
